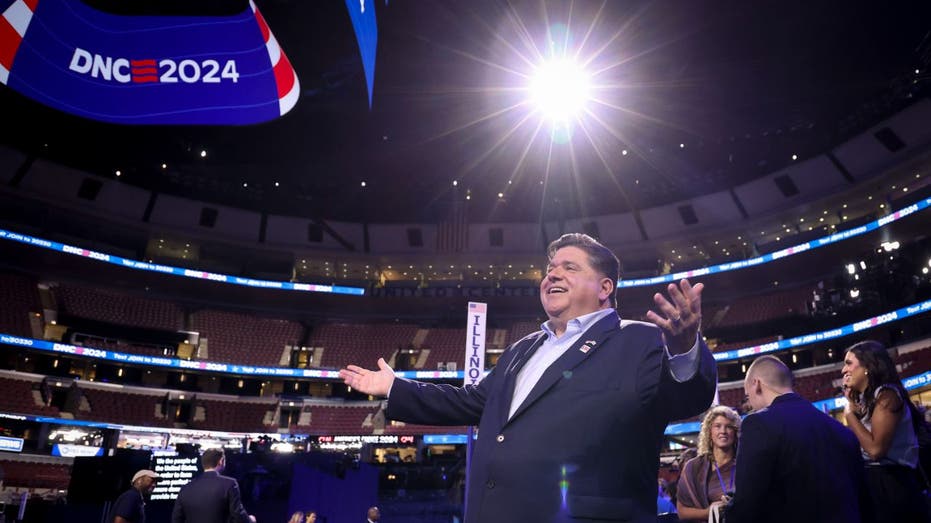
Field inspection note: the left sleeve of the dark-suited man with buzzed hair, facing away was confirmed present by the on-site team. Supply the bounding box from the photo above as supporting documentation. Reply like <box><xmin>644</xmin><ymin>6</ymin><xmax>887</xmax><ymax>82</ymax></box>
<box><xmin>725</xmin><ymin>414</ymin><xmax>779</xmax><ymax>523</ymax></box>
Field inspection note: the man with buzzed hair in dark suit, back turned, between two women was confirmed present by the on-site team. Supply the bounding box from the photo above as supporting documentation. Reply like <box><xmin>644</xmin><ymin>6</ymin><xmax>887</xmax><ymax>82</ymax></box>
<box><xmin>725</xmin><ymin>356</ymin><xmax>868</xmax><ymax>523</ymax></box>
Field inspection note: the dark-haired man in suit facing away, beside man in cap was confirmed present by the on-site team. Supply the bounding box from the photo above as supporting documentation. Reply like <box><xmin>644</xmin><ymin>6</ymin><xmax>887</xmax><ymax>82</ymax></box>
<box><xmin>171</xmin><ymin>449</ymin><xmax>255</xmax><ymax>523</ymax></box>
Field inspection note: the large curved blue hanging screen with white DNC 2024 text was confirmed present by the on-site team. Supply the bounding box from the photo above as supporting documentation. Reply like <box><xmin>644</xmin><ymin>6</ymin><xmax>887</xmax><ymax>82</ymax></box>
<box><xmin>0</xmin><ymin>0</ymin><xmax>300</xmax><ymax>125</ymax></box>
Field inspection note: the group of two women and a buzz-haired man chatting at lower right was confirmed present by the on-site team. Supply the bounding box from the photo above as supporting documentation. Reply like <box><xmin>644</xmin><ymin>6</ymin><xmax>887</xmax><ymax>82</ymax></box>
<box><xmin>657</xmin><ymin>341</ymin><xmax>931</xmax><ymax>523</ymax></box>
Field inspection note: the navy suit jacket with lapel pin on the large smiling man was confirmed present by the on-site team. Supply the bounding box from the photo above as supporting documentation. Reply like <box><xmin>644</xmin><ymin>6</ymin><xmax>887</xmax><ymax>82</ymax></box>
<box><xmin>387</xmin><ymin>314</ymin><xmax>717</xmax><ymax>523</ymax></box>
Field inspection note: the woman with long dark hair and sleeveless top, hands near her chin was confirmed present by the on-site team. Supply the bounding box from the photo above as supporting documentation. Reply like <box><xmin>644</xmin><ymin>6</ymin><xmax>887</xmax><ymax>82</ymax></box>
<box><xmin>841</xmin><ymin>341</ymin><xmax>928</xmax><ymax>523</ymax></box>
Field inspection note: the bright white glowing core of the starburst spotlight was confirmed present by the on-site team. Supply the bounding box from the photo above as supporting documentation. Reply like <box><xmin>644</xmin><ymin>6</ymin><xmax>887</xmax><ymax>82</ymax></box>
<box><xmin>530</xmin><ymin>59</ymin><xmax>590</xmax><ymax>122</ymax></box>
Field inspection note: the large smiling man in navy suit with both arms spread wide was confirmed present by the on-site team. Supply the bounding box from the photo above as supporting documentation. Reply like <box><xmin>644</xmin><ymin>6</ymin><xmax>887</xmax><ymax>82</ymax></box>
<box><xmin>340</xmin><ymin>234</ymin><xmax>716</xmax><ymax>523</ymax></box>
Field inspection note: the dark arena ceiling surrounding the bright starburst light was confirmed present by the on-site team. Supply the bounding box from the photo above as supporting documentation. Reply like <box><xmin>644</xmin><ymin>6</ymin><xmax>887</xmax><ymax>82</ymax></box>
<box><xmin>0</xmin><ymin>0</ymin><xmax>931</xmax><ymax>222</ymax></box>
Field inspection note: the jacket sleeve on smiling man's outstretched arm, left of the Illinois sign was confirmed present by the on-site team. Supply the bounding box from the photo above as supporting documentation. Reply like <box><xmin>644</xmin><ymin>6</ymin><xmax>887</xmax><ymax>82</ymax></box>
<box><xmin>385</xmin><ymin>367</ymin><xmax>498</xmax><ymax>425</ymax></box>
